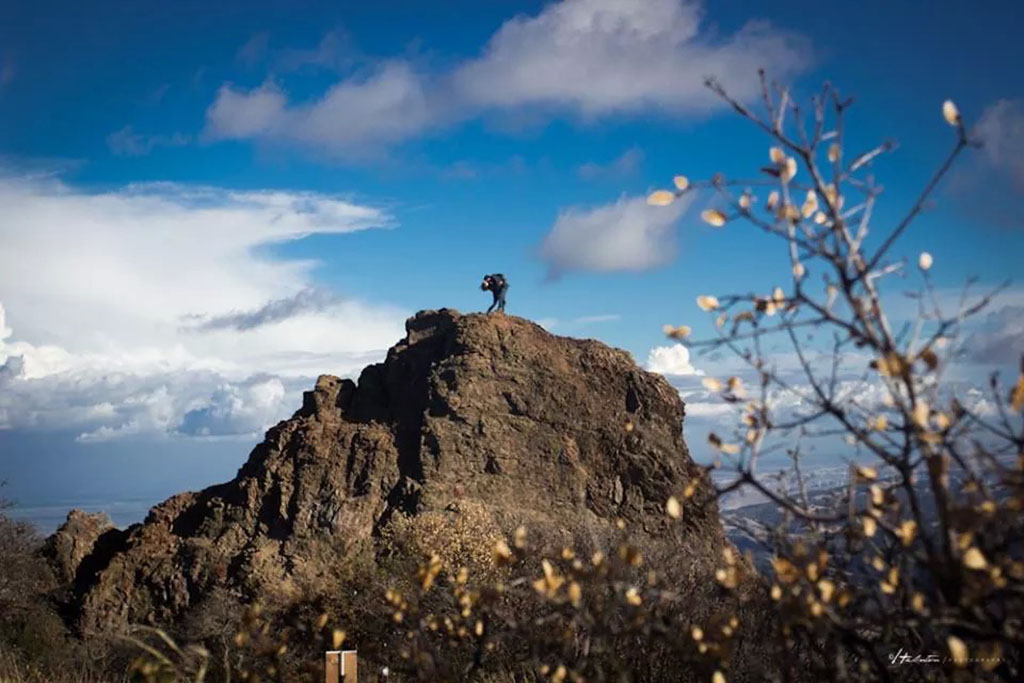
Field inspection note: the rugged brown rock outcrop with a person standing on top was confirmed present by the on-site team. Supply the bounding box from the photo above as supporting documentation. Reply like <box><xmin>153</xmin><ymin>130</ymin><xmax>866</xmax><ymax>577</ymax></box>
<box><xmin>48</xmin><ymin>309</ymin><xmax>725</xmax><ymax>632</ymax></box>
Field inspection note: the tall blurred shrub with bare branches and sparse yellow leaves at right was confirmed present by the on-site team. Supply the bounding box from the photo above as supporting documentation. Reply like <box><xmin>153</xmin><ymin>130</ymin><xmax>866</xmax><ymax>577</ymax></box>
<box><xmin>651</xmin><ymin>72</ymin><xmax>1024</xmax><ymax>681</ymax></box>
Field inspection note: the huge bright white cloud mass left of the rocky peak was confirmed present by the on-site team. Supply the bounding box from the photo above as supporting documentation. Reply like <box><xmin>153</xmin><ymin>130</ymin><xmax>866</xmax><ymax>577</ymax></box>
<box><xmin>0</xmin><ymin>177</ymin><xmax>404</xmax><ymax>439</ymax></box>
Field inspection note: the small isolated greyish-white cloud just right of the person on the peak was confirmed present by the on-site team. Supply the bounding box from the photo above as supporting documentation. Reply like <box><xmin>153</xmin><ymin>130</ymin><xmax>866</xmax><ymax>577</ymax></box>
<box><xmin>539</xmin><ymin>192</ymin><xmax>692</xmax><ymax>275</ymax></box>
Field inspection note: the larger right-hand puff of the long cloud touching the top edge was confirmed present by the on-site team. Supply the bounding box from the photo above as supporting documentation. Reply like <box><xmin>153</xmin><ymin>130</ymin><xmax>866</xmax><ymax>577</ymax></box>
<box><xmin>455</xmin><ymin>0</ymin><xmax>807</xmax><ymax>116</ymax></box>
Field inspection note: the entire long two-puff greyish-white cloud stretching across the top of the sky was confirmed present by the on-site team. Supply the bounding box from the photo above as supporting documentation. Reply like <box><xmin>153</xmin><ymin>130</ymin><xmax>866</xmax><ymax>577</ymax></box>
<box><xmin>206</xmin><ymin>0</ymin><xmax>809</xmax><ymax>153</ymax></box>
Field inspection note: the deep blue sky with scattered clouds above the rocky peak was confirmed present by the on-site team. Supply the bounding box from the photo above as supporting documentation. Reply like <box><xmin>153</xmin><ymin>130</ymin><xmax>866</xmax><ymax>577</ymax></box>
<box><xmin>0</xmin><ymin>0</ymin><xmax>1024</xmax><ymax>528</ymax></box>
